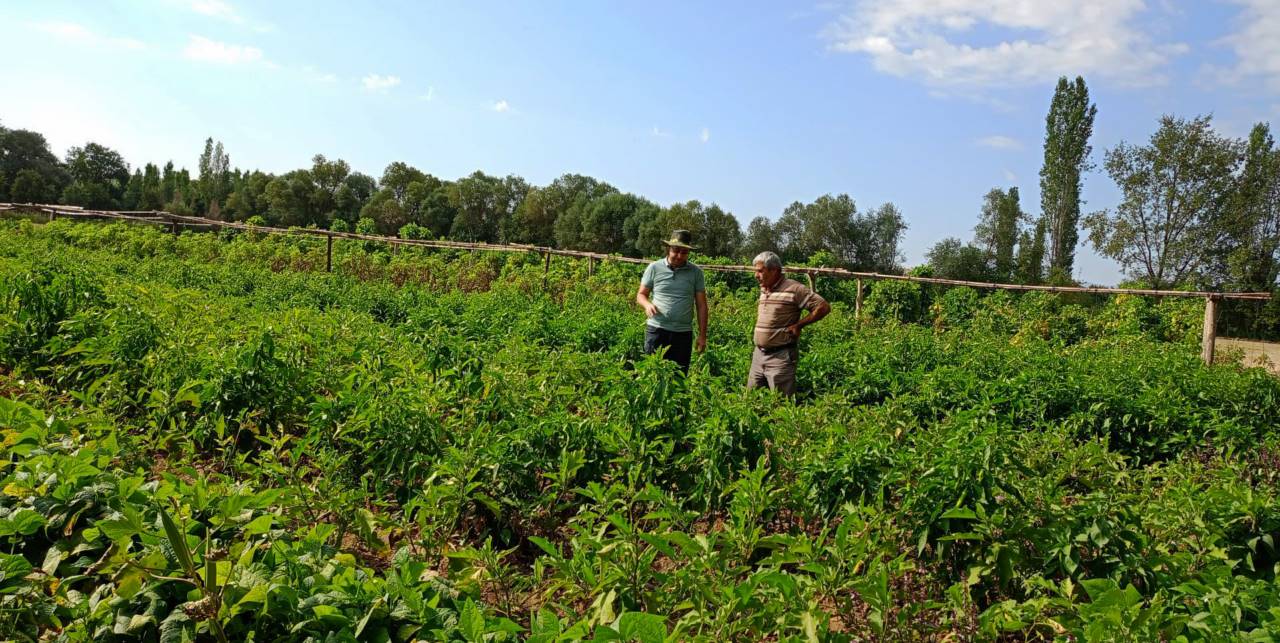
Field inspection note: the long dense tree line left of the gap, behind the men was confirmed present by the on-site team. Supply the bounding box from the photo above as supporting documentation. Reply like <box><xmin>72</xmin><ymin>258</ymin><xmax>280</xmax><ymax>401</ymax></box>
<box><xmin>0</xmin><ymin>127</ymin><xmax>906</xmax><ymax>272</ymax></box>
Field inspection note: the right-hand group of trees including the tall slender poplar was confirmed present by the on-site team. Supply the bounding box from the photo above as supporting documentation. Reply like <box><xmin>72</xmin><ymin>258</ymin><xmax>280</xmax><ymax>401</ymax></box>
<box><xmin>927</xmin><ymin>77</ymin><xmax>1280</xmax><ymax>304</ymax></box>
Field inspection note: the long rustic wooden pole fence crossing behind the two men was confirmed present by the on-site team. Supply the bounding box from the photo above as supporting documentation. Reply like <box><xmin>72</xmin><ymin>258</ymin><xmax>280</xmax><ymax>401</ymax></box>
<box><xmin>0</xmin><ymin>202</ymin><xmax>1271</xmax><ymax>364</ymax></box>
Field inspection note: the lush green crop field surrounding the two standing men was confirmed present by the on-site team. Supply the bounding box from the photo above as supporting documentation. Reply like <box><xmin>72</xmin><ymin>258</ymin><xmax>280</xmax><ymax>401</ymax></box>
<box><xmin>0</xmin><ymin>222</ymin><xmax>1280</xmax><ymax>642</ymax></box>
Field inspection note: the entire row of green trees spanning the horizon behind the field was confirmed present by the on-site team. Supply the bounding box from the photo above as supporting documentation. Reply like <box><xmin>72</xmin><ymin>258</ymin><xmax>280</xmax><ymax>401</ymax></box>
<box><xmin>0</xmin><ymin>77</ymin><xmax>1280</xmax><ymax>299</ymax></box>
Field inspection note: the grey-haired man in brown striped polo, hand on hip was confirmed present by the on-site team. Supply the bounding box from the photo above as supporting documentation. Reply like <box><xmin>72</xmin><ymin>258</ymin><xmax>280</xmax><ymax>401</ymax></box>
<box><xmin>746</xmin><ymin>252</ymin><xmax>831</xmax><ymax>397</ymax></box>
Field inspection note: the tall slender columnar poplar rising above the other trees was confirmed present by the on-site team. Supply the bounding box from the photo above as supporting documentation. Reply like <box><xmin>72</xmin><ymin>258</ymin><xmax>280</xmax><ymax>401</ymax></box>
<box><xmin>1041</xmin><ymin>76</ymin><xmax>1098</xmax><ymax>275</ymax></box>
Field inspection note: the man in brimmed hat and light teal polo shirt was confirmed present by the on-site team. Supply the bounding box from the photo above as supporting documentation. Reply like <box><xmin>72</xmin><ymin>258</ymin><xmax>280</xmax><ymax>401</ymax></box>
<box><xmin>636</xmin><ymin>231</ymin><xmax>707</xmax><ymax>374</ymax></box>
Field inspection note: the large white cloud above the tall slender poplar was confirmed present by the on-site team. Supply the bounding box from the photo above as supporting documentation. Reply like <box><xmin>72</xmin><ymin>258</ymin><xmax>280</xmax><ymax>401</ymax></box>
<box><xmin>826</xmin><ymin>0</ymin><xmax>1187</xmax><ymax>90</ymax></box>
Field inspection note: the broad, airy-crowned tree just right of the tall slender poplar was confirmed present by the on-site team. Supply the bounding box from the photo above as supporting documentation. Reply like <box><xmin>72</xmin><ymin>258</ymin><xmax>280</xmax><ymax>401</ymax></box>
<box><xmin>1085</xmin><ymin>115</ymin><xmax>1240</xmax><ymax>288</ymax></box>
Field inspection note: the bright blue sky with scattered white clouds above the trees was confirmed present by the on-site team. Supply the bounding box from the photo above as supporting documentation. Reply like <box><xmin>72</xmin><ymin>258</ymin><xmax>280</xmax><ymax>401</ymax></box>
<box><xmin>0</xmin><ymin>0</ymin><xmax>1280</xmax><ymax>283</ymax></box>
